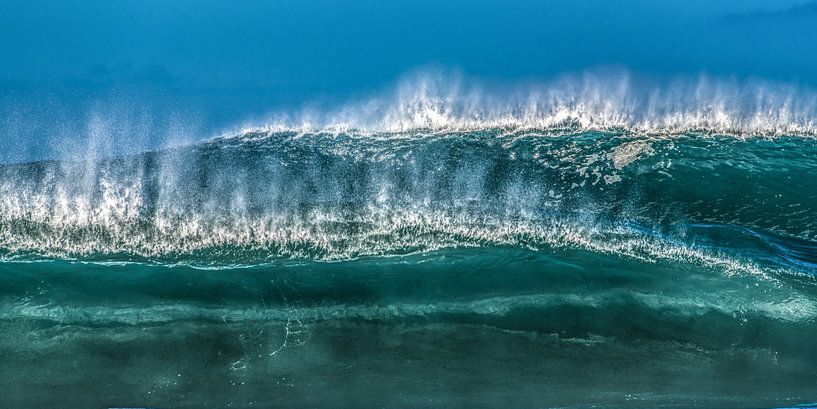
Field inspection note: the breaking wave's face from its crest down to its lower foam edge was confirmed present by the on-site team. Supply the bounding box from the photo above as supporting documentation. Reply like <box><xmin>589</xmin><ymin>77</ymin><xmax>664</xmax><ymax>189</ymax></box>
<box><xmin>0</xmin><ymin>129</ymin><xmax>817</xmax><ymax>274</ymax></box>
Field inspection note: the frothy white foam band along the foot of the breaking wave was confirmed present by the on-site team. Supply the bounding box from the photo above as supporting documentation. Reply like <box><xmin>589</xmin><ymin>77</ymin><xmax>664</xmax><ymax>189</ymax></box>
<box><xmin>0</xmin><ymin>190</ymin><xmax>796</xmax><ymax>280</ymax></box>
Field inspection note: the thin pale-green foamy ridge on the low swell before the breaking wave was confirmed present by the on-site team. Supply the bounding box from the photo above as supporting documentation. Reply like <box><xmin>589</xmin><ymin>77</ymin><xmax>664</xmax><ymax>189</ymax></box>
<box><xmin>0</xmin><ymin>288</ymin><xmax>817</xmax><ymax>325</ymax></box>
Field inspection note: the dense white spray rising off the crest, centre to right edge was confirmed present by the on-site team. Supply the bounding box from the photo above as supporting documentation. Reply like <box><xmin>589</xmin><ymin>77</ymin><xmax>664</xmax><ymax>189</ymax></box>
<box><xmin>230</xmin><ymin>70</ymin><xmax>817</xmax><ymax>136</ymax></box>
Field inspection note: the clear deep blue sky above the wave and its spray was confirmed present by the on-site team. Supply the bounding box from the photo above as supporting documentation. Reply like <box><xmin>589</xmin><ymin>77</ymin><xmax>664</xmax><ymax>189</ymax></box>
<box><xmin>0</xmin><ymin>0</ymin><xmax>817</xmax><ymax>161</ymax></box>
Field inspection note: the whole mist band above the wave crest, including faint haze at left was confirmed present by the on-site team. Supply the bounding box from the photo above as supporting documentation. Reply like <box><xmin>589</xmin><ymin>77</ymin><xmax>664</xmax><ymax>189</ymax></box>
<box><xmin>6</xmin><ymin>69</ymin><xmax>817</xmax><ymax>162</ymax></box>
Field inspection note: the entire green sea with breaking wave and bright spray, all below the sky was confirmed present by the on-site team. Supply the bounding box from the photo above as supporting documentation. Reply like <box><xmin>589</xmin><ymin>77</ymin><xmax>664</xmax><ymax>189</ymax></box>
<box><xmin>0</xmin><ymin>77</ymin><xmax>817</xmax><ymax>408</ymax></box>
